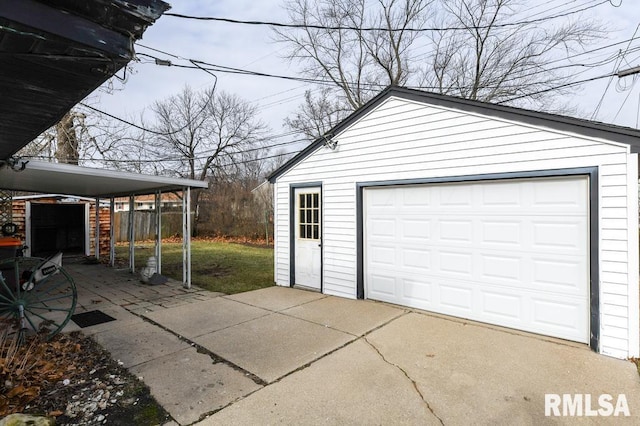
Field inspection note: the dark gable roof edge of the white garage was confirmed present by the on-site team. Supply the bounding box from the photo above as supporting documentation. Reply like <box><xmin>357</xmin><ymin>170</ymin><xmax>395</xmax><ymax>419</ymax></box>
<box><xmin>267</xmin><ymin>86</ymin><xmax>640</xmax><ymax>183</ymax></box>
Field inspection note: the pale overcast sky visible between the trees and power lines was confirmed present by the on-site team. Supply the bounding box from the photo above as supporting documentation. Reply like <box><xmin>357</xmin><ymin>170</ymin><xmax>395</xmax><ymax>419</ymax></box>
<box><xmin>91</xmin><ymin>0</ymin><xmax>640</xmax><ymax>156</ymax></box>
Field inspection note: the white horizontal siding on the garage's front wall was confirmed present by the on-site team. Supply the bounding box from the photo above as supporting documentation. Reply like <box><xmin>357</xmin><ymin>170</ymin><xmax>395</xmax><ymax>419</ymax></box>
<box><xmin>275</xmin><ymin>98</ymin><xmax>638</xmax><ymax>357</ymax></box>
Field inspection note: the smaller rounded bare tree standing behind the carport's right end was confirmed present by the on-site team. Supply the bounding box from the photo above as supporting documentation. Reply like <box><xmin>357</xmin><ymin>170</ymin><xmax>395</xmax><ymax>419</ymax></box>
<box><xmin>150</xmin><ymin>86</ymin><xmax>267</xmax><ymax>232</ymax></box>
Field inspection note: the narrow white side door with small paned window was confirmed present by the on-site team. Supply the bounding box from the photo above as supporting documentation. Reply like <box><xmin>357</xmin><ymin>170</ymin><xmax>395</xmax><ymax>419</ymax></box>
<box><xmin>294</xmin><ymin>187</ymin><xmax>322</xmax><ymax>290</ymax></box>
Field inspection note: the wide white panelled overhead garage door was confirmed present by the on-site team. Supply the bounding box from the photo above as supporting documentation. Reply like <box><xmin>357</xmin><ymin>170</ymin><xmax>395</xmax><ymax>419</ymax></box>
<box><xmin>363</xmin><ymin>176</ymin><xmax>589</xmax><ymax>343</ymax></box>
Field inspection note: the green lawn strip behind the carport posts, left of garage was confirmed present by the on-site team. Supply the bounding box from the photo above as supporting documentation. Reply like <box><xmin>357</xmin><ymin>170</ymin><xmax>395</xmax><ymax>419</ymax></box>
<box><xmin>116</xmin><ymin>241</ymin><xmax>273</xmax><ymax>294</ymax></box>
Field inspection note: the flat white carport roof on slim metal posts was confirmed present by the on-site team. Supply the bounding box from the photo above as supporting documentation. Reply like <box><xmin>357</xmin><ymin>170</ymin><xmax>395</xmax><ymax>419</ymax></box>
<box><xmin>0</xmin><ymin>161</ymin><xmax>208</xmax><ymax>198</ymax></box>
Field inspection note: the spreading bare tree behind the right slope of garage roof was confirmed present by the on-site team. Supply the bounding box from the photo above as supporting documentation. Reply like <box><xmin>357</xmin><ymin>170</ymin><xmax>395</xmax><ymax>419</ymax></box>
<box><xmin>420</xmin><ymin>0</ymin><xmax>604</xmax><ymax>110</ymax></box>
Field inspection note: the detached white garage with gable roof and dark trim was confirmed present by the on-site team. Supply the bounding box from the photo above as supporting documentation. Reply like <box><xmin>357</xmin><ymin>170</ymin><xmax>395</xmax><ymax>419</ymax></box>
<box><xmin>269</xmin><ymin>87</ymin><xmax>640</xmax><ymax>358</ymax></box>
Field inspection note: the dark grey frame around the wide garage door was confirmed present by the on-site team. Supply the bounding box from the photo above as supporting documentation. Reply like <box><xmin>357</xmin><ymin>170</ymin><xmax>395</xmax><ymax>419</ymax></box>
<box><xmin>356</xmin><ymin>166</ymin><xmax>600</xmax><ymax>352</ymax></box>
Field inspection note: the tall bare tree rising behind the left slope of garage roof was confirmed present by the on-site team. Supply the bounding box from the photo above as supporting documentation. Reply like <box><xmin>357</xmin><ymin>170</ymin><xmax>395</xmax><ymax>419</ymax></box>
<box><xmin>276</xmin><ymin>0</ymin><xmax>433</xmax><ymax>110</ymax></box>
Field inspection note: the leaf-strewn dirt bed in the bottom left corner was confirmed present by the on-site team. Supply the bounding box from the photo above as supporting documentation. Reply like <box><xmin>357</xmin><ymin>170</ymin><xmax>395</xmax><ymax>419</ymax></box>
<box><xmin>0</xmin><ymin>332</ymin><xmax>171</xmax><ymax>425</ymax></box>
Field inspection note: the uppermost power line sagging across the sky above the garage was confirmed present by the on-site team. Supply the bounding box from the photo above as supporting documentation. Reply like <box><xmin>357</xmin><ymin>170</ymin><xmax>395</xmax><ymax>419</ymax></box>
<box><xmin>163</xmin><ymin>0</ymin><xmax>610</xmax><ymax>32</ymax></box>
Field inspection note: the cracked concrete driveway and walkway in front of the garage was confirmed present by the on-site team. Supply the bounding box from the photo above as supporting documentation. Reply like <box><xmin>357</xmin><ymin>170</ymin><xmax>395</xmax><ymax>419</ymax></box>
<box><xmin>65</xmin><ymin>264</ymin><xmax>640</xmax><ymax>425</ymax></box>
